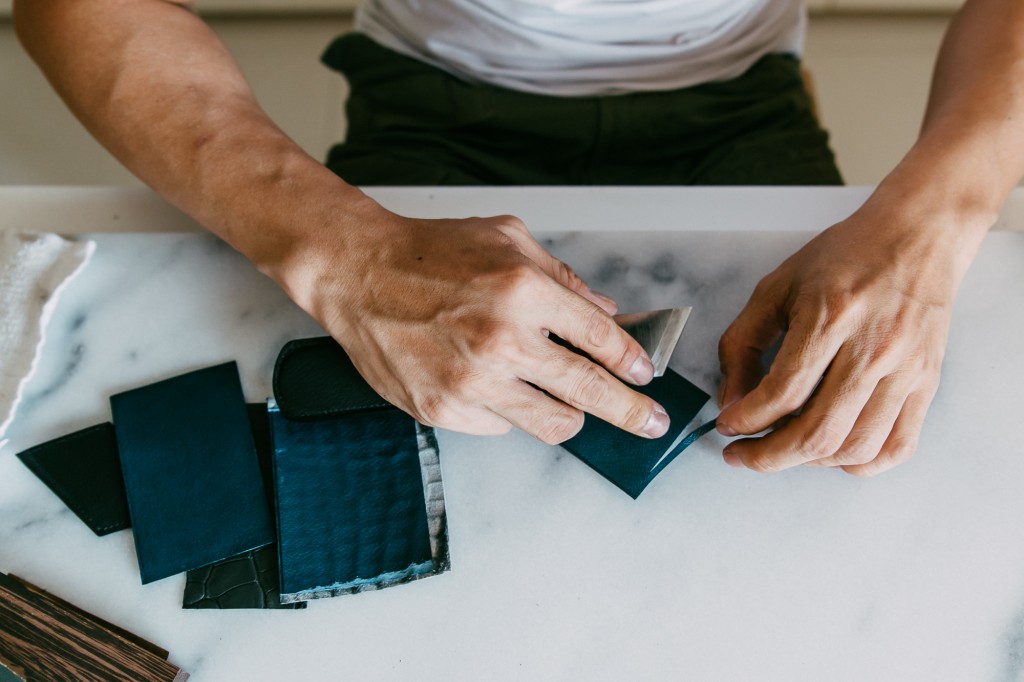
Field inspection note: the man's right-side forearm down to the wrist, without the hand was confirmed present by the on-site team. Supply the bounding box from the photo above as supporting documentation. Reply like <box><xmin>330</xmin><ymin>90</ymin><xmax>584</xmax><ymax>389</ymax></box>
<box><xmin>877</xmin><ymin>0</ymin><xmax>1024</xmax><ymax>240</ymax></box>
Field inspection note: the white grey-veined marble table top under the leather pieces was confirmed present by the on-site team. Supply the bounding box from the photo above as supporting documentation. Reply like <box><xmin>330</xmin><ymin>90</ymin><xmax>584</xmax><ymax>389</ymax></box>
<box><xmin>0</xmin><ymin>188</ymin><xmax>1024</xmax><ymax>681</ymax></box>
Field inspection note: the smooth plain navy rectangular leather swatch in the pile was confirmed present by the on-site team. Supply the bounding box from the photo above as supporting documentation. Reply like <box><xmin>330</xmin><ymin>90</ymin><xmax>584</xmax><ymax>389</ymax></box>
<box><xmin>111</xmin><ymin>363</ymin><xmax>273</xmax><ymax>584</ymax></box>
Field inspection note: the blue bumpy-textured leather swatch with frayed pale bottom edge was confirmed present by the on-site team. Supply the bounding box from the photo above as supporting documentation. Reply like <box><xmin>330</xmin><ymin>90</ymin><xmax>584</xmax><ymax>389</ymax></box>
<box><xmin>269</xmin><ymin>402</ymin><xmax>437</xmax><ymax>603</ymax></box>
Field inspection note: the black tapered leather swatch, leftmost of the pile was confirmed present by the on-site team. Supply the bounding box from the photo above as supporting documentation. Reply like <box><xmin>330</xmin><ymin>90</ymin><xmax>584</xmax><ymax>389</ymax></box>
<box><xmin>17</xmin><ymin>422</ymin><xmax>131</xmax><ymax>536</ymax></box>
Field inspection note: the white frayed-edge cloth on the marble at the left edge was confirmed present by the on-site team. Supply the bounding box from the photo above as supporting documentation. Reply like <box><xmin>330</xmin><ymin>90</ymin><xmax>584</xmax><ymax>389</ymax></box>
<box><xmin>0</xmin><ymin>230</ymin><xmax>95</xmax><ymax>437</ymax></box>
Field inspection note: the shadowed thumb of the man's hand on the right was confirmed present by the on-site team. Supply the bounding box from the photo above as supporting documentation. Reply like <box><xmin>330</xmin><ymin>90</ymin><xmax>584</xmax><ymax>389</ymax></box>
<box><xmin>718</xmin><ymin>280</ymin><xmax>785</xmax><ymax>408</ymax></box>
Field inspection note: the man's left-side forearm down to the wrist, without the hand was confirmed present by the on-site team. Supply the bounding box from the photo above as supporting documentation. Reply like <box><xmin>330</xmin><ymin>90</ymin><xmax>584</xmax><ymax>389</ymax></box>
<box><xmin>14</xmin><ymin>0</ymin><xmax>368</xmax><ymax>273</ymax></box>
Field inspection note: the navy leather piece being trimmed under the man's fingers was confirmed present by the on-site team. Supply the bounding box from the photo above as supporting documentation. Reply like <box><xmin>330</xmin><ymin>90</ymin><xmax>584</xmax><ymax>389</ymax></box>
<box><xmin>562</xmin><ymin>370</ymin><xmax>710</xmax><ymax>500</ymax></box>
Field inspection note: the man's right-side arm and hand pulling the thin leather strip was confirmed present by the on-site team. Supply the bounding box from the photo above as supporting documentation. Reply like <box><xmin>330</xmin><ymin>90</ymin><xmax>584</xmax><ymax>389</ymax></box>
<box><xmin>719</xmin><ymin>0</ymin><xmax>1024</xmax><ymax>474</ymax></box>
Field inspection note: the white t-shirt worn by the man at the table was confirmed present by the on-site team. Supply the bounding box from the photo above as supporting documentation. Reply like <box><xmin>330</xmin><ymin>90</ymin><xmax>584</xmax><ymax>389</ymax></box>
<box><xmin>355</xmin><ymin>0</ymin><xmax>806</xmax><ymax>95</ymax></box>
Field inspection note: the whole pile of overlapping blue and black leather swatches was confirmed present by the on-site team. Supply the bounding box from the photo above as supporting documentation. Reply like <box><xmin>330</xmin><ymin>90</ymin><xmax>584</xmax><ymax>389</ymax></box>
<box><xmin>18</xmin><ymin>338</ymin><xmax>450</xmax><ymax>608</ymax></box>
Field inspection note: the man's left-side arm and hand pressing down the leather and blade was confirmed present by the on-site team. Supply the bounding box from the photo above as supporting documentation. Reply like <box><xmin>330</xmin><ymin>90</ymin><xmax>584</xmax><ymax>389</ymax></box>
<box><xmin>14</xmin><ymin>0</ymin><xmax>669</xmax><ymax>442</ymax></box>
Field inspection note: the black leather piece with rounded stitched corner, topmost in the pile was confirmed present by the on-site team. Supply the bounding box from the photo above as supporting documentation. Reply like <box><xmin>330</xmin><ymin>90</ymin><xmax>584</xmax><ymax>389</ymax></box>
<box><xmin>273</xmin><ymin>336</ymin><xmax>392</xmax><ymax>420</ymax></box>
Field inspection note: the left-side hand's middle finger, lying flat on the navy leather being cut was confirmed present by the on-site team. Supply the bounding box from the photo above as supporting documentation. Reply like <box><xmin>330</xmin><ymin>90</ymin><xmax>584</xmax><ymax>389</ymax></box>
<box><xmin>516</xmin><ymin>342</ymin><xmax>669</xmax><ymax>442</ymax></box>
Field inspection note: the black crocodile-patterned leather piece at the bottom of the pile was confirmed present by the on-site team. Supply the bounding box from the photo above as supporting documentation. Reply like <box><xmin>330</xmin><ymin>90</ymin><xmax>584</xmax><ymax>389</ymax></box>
<box><xmin>181</xmin><ymin>545</ymin><xmax>306</xmax><ymax>608</ymax></box>
